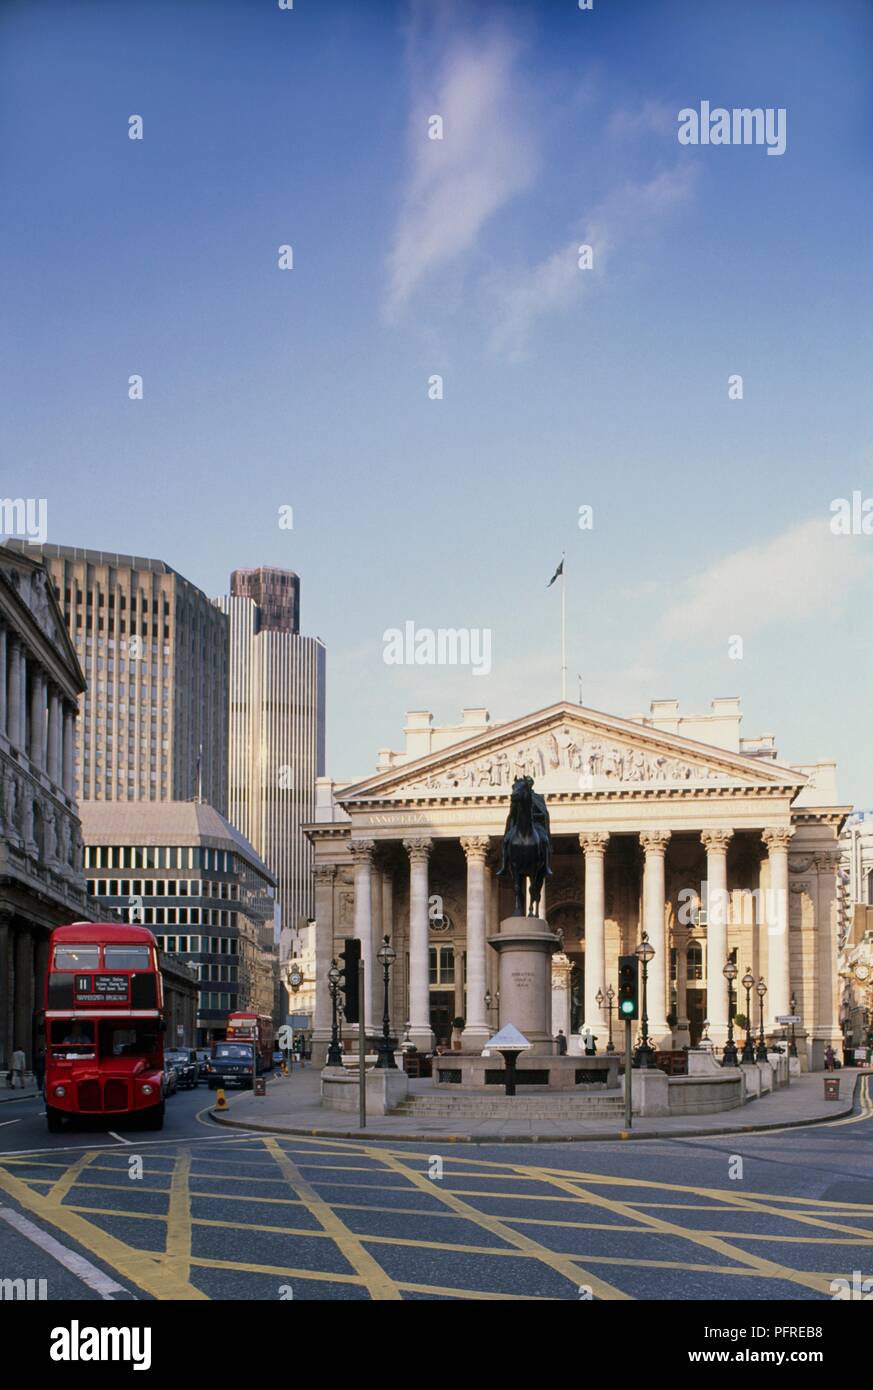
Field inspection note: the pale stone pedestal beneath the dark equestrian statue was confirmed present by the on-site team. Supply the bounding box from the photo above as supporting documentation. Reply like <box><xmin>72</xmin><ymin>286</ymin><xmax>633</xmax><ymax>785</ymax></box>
<box><xmin>488</xmin><ymin>917</ymin><xmax>559</xmax><ymax>1056</ymax></box>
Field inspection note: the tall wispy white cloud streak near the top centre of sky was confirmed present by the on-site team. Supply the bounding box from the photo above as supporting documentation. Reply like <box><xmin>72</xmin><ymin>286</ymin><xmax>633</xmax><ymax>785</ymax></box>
<box><xmin>386</xmin><ymin>32</ymin><xmax>535</xmax><ymax>316</ymax></box>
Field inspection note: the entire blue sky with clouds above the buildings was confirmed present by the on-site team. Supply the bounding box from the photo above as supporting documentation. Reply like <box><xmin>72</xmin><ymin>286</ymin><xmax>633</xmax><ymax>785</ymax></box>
<box><xmin>0</xmin><ymin>0</ymin><xmax>873</xmax><ymax>805</ymax></box>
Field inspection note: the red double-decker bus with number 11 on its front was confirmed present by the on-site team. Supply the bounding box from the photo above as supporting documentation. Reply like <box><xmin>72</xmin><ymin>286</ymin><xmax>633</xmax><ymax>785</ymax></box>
<box><xmin>44</xmin><ymin>922</ymin><xmax>164</xmax><ymax>1134</ymax></box>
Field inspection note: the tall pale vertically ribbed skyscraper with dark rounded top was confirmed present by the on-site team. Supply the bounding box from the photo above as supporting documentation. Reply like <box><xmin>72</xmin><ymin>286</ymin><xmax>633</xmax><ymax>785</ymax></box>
<box><xmin>214</xmin><ymin>570</ymin><xmax>325</xmax><ymax>959</ymax></box>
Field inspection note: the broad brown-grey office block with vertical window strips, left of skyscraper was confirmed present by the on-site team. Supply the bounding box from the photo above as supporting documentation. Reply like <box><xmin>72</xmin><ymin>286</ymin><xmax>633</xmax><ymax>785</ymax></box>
<box><xmin>8</xmin><ymin>541</ymin><xmax>228</xmax><ymax>813</ymax></box>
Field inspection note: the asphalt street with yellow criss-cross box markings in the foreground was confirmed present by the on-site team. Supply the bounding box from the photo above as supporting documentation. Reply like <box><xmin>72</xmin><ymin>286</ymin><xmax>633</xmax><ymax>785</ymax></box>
<box><xmin>0</xmin><ymin>1077</ymin><xmax>873</xmax><ymax>1301</ymax></box>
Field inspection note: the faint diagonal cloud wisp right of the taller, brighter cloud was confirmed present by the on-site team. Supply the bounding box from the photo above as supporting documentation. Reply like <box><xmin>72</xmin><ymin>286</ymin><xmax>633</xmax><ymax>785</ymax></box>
<box><xmin>489</xmin><ymin>163</ymin><xmax>695</xmax><ymax>357</ymax></box>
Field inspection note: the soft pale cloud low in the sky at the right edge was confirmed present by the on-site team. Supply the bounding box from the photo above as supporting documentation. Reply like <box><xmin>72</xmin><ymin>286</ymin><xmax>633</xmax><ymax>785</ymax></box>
<box><xmin>659</xmin><ymin>517</ymin><xmax>873</xmax><ymax>641</ymax></box>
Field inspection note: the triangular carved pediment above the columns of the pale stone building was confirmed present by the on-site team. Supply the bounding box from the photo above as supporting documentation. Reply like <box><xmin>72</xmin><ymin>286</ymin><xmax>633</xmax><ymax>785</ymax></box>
<box><xmin>338</xmin><ymin>702</ymin><xmax>806</xmax><ymax>808</ymax></box>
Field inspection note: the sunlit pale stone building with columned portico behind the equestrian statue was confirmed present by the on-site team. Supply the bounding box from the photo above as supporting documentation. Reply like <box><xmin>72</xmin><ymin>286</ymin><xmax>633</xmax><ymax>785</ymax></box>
<box><xmin>307</xmin><ymin>699</ymin><xmax>851</xmax><ymax>1068</ymax></box>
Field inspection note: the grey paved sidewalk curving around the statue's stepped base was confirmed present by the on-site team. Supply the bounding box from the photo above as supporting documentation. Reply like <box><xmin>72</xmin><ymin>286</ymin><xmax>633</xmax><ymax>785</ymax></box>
<box><xmin>210</xmin><ymin>1068</ymin><xmax>873</xmax><ymax>1144</ymax></box>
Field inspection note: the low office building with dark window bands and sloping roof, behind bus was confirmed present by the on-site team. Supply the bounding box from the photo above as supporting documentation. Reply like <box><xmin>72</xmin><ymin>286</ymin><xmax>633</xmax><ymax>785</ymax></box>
<box><xmin>82</xmin><ymin>801</ymin><xmax>278</xmax><ymax>1045</ymax></box>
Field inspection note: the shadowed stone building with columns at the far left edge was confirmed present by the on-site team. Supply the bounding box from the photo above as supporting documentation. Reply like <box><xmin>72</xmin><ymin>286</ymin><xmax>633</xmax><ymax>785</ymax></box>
<box><xmin>0</xmin><ymin>546</ymin><xmax>99</xmax><ymax>1069</ymax></box>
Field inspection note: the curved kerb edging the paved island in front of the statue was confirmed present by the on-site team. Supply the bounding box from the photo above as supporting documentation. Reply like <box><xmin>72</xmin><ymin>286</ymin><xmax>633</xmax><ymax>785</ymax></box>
<box><xmin>209</xmin><ymin>1076</ymin><xmax>862</xmax><ymax>1144</ymax></box>
